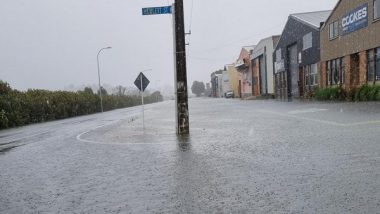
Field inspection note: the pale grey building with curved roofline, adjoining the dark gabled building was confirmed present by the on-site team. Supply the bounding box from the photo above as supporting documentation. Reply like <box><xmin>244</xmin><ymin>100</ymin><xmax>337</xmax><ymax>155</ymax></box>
<box><xmin>251</xmin><ymin>36</ymin><xmax>280</xmax><ymax>96</ymax></box>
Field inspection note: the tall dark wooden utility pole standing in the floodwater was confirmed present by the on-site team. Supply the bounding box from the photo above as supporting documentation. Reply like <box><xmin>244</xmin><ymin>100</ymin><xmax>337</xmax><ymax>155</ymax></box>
<box><xmin>173</xmin><ymin>0</ymin><xmax>190</xmax><ymax>136</ymax></box>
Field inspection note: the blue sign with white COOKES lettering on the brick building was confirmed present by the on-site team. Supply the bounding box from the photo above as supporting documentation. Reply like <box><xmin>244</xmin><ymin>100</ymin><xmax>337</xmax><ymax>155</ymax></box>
<box><xmin>341</xmin><ymin>3</ymin><xmax>368</xmax><ymax>35</ymax></box>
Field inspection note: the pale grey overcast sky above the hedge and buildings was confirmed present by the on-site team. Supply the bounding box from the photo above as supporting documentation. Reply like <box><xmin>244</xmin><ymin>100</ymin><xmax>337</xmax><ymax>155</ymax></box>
<box><xmin>0</xmin><ymin>0</ymin><xmax>337</xmax><ymax>90</ymax></box>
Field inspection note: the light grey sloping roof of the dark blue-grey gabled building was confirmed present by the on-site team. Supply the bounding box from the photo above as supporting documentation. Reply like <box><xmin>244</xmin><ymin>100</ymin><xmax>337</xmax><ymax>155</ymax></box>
<box><xmin>290</xmin><ymin>10</ymin><xmax>332</xmax><ymax>29</ymax></box>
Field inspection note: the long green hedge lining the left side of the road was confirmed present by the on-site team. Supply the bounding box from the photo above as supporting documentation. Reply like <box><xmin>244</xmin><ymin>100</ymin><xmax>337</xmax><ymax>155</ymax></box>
<box><xmin>0</xmin><ymin>80</ymin><xmax>163</xmax><ymax>129</ymax></box>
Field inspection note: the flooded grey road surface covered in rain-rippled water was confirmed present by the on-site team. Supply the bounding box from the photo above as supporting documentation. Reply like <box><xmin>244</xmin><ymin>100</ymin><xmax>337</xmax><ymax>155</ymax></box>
<box><xmin>0</xmin><ymin>98</ymin><xmax>380</xmax><ymax>214</ymax></box>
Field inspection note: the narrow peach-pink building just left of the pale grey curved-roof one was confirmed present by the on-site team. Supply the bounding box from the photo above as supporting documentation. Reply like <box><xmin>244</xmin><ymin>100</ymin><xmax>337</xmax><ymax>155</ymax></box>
<box><xmin>235</xmin><ymin>46</ymin><xmax>255</xmax><ymax>98</ymax></box>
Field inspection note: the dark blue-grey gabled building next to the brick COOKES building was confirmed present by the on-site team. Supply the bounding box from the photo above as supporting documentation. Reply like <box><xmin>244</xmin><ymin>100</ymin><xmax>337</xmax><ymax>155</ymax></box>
<box><xmin>274</xmin><ymin>11</ymin><xmax>331</xmax><ymax>100</ymax></box>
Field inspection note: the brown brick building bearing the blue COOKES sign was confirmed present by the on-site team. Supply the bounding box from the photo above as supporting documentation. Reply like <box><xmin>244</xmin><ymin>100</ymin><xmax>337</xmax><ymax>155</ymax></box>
<box><xmin>320</xmin><ymin>0</ymin><xmax>380</xmax><ymax>91</ymax></box>
